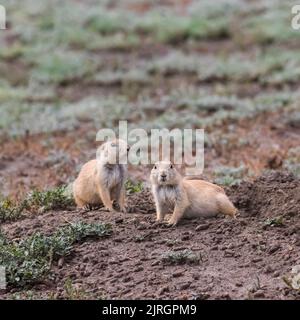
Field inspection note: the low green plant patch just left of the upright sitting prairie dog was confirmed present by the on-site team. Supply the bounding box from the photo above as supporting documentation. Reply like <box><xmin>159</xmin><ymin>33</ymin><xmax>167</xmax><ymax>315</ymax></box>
<box><xmin>26</xmin><ymin>186</ymin><xmax>74</xmax><ymax>212</ymax></box>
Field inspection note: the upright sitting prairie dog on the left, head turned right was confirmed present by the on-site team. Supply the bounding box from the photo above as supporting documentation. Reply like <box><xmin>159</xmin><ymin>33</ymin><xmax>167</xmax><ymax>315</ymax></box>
<box><xmin>73</xmin><ymin>140</ymin><xmax>129</xmax><ymax>212</ymax></box>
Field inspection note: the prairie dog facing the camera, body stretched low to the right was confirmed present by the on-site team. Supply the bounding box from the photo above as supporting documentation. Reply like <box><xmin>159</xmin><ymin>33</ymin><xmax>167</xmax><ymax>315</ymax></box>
<box><xmin>150</xmin><ymin>161</ymin><xmax>237</xmax><ymax>225</ymax></box>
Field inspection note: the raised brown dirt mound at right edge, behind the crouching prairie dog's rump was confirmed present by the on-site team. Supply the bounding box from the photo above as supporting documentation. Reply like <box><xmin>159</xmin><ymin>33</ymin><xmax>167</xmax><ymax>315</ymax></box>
<box><xmin>227</xmin><ymin>171</ymin><xmax>300</xmax><ymax>217</ymax></box>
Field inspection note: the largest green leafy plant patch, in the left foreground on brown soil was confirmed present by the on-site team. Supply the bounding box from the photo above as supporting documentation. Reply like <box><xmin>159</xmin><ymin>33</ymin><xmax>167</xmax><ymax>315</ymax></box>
<box><xmin>0</xmin><ymin>222</ymin><xmax>112</xmax><ymax>286</ymax></box>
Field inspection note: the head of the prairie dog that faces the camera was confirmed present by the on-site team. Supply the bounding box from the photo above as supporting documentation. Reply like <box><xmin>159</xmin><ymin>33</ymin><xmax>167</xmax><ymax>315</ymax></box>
<box><xmin>150</xmin><ymin>161</ymin><xmax>181</xmax><ymax>186</ymax></box>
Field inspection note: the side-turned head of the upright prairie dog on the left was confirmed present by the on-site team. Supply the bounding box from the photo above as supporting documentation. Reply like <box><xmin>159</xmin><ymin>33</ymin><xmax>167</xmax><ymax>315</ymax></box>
<box><xmin>97</xmin><ymin>139</ymin><xmax>129</xmax><ymax>164</ymax></box>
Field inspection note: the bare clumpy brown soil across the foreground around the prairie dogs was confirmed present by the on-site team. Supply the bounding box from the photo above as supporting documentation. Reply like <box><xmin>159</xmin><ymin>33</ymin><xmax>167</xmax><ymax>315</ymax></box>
<box><xmin>0</xmin><ymin>172</ymin><xmax>300</xmax><ymax>299</ymax></box>
